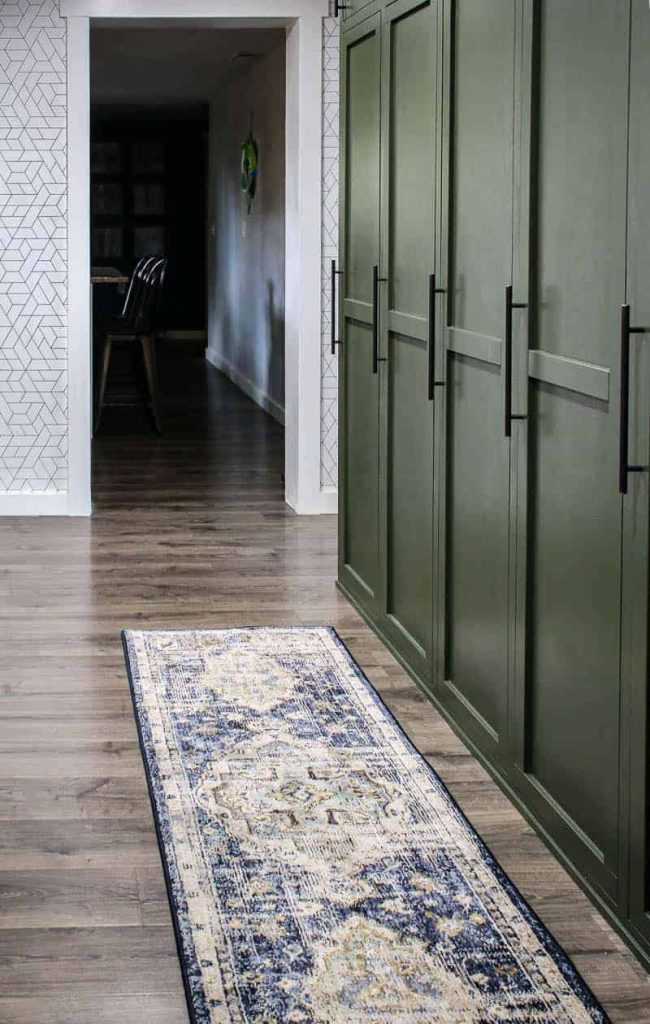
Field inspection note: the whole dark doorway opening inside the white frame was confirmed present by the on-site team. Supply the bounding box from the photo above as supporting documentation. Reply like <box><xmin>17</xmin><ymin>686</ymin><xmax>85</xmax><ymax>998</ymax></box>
<box><xmin>90</xmin><ymin>22</ymin><xmax>286</xmax><ymax>501</ymax></box>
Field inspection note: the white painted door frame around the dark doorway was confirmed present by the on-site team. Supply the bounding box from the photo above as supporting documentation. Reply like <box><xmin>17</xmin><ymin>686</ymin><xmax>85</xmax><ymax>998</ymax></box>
<box><xmin>60</xmin><ymin>0</ymin><xmax>335</xmax><ymax>515</ymax></box>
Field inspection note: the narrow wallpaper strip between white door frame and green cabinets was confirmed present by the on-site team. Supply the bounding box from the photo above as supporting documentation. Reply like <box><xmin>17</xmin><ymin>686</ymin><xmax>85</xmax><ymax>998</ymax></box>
<box><xmin>320</xmin><ymin>17</ymin><xmax>341</xmax><ymax>487</ymax></box>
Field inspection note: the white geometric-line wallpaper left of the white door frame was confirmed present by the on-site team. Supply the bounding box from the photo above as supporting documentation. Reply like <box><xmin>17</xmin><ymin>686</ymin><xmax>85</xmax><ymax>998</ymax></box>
<box><xmin>0</xmin><ymin>0</ymin><xmax>68</xmax><ymax>493</ymax></box>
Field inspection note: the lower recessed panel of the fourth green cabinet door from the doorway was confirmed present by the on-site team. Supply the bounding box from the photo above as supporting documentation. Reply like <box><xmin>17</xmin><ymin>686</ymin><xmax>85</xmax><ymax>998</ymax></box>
<box><xmin>526</xmin><ymin>385</ymin><xmax>620</xmax><ymax>863</ymax></box>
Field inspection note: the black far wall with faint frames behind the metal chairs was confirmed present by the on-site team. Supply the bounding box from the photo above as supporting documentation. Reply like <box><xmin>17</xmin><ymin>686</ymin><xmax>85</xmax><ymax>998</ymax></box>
<box><xmin>90</xmin><ymin>105</ymin><xmax>208</xmax><ymax>337</ymax></box>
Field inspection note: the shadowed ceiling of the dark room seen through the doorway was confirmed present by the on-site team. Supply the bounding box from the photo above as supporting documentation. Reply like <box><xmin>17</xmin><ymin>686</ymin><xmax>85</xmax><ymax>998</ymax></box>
<box><xmin>90</xmin><ymin>22</ymin><xmax>285</xmax><ymax>106</ymax></box>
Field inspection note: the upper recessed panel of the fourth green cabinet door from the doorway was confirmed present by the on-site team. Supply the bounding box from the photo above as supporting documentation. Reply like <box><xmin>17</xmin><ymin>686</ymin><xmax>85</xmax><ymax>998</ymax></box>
<box><xmin>535</xmin><ymin>0</ymin><xmax>629</xmax><ymax>367</ymax></box>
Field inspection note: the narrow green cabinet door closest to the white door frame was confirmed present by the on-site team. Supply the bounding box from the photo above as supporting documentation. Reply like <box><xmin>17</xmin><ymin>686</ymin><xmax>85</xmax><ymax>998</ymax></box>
<box><xmin>339</xmin><ymin>14</ymin><xmax>381</xmax><ymax>611</ymax></box>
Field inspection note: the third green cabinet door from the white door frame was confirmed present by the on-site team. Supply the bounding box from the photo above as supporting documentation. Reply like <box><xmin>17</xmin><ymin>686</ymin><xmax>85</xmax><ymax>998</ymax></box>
<box><xmin>436</xmin><ymin>0</ymin><xmax>520</xmax><ymax>757</ymax></box>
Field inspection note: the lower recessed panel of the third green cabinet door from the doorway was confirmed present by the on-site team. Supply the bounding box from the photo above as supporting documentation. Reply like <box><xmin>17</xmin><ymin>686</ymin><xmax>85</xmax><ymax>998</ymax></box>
<box><xmin>448</xmin><ymin>354</ymin><xmax>510</xmax><ymax>749</ymax></box>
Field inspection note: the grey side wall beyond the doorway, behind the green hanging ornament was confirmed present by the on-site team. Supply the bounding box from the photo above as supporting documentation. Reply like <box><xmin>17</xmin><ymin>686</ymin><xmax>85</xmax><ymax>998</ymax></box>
<box><xmin>208</xmin><ymin>40</ymin><xmax>286</xmax><ymax>422</ymax></box>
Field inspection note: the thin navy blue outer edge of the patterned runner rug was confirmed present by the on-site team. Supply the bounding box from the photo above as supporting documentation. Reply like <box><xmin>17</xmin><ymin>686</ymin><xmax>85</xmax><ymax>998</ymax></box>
<box><xmin>121</xmin><ymin>624</ymin><xmax>612</xmax><ymax>1024</ymax></box>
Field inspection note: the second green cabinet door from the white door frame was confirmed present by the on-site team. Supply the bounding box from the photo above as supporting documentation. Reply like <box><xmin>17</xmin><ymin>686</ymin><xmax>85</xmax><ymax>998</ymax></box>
<box><xmin>380</xmin><ymin>0</ymin><xmax>438</xmax><ymax>682</ymax></box>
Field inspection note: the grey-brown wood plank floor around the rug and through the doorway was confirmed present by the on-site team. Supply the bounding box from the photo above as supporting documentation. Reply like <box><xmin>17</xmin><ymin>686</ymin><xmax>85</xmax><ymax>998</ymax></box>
<box><xmin>0</xmin><ymin>353</ymin><xmax>650</xmax><ymax>1024</ymax></box>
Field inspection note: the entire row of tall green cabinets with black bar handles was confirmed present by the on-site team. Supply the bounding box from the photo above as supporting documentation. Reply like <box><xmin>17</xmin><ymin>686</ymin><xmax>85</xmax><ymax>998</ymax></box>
<box><xmin>333</xmin><ymin>0</ymin><xmax>650</xmax><ymax>965</ymax></box>
